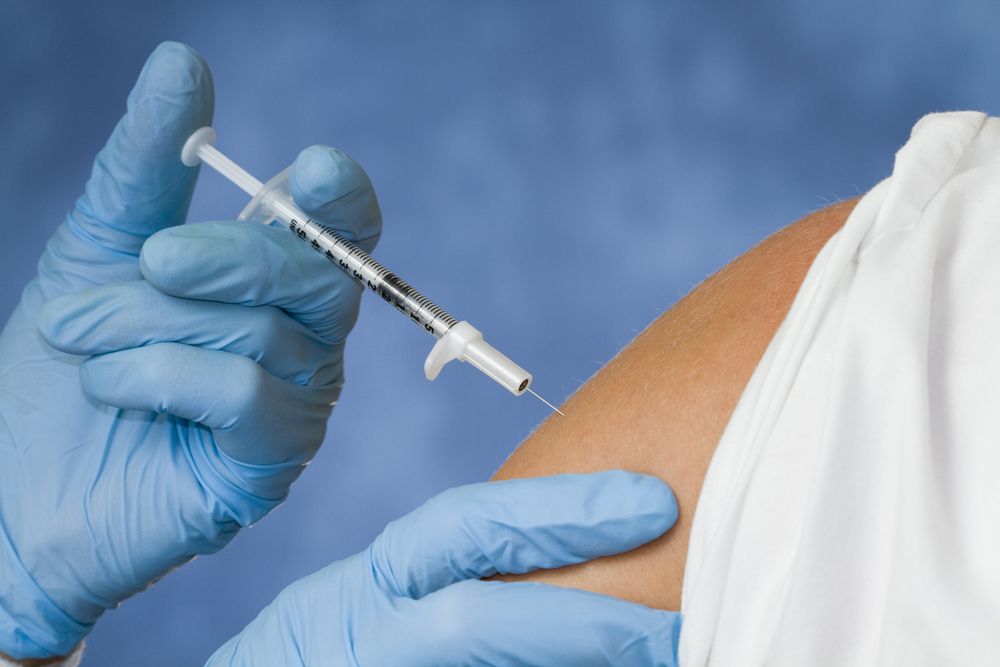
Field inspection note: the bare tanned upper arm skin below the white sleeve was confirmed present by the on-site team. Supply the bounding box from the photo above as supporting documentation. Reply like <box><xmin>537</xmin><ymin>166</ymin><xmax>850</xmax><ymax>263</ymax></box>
<box><xmin>494</xmin><ymin>199</ymin><xmax>857</xmax><ymax>609</ymax></box>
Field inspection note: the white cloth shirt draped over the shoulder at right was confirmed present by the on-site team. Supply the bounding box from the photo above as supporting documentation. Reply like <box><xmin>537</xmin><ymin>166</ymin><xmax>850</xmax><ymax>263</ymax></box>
<box><xmin>680</xmin><ymin>112</ymin><xmax>1000</xmax><ymax>667</ymax></box>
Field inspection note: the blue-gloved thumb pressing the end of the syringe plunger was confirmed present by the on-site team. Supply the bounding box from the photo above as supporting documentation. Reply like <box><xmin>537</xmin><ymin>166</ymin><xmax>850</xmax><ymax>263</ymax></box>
<box><xmin>67</xmin><ymin>42</ymin><xmax>215</xmax><ymax>264</ymax></box>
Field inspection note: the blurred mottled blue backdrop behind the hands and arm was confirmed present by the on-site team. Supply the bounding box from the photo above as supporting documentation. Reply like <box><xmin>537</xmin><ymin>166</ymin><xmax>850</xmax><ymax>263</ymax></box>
<box><xmin>0</xmin><ymin>0</ymin><xmax>1000</xmax><ymax>667</ymax></box>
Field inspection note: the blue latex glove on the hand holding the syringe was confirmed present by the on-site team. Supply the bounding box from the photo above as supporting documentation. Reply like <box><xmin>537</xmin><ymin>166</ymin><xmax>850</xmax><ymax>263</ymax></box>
<box><xmin>0</xmin><ymin>43</ymin><xmax>381</xmax><ymax>658</ymax></box>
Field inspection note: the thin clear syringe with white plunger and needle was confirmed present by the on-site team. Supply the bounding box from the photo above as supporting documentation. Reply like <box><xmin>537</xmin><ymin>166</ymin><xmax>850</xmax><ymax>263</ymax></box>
<box><xmin>181</xmin><ymin>127</ymin><xmax>562</xmax><ymax>414</ymax></box>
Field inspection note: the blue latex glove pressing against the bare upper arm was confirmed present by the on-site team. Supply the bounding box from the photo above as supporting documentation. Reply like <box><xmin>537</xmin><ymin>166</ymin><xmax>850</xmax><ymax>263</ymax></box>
<box><xmin>207</xmin><ymin>471</ymin><xmax>681</xmax><ymax>667</ymax></box>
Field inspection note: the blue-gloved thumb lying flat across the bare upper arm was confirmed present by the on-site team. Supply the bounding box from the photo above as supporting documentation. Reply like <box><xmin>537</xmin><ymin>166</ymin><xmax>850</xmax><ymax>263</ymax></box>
<box><xmin>369</xmin><ymin>470</ymin><xmax>677</xmax><ymax>598</ymax></box>
